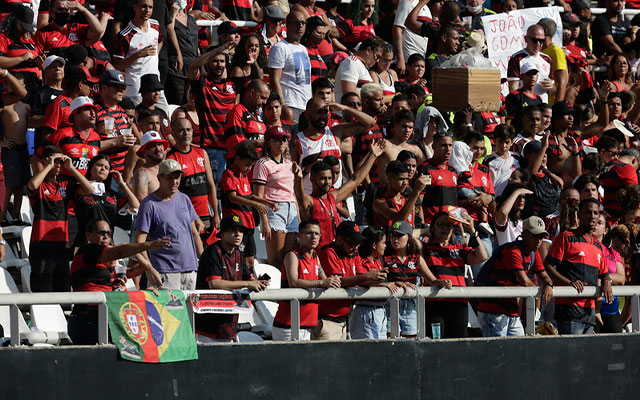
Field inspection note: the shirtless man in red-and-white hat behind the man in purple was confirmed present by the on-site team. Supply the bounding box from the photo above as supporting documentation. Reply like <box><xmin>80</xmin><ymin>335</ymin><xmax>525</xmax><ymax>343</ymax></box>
<box><xmin>133</xmin><ymin>131</ymin><xmax>169</xmax><ymax>201</ymax></box>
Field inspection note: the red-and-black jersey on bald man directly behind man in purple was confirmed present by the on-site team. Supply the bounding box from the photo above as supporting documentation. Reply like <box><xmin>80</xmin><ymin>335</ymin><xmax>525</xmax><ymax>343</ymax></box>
<box><xmin>167</xmin><ymin>146</ymin><xmax>210</xmax><ymax>218</ymax></box>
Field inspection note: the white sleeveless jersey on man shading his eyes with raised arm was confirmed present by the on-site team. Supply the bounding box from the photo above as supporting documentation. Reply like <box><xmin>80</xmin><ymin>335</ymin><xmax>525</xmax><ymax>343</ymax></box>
<box><xmin>296</xmin><ymin>126</ymin><xmax>342</xmax><ymax>194</ymax></box>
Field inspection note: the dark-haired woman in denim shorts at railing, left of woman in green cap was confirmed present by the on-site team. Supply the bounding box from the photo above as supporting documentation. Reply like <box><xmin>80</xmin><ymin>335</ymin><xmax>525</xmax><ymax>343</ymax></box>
<box><xmin>349</xmin><ymin>226</ymin><xmax>399</xmax><ymax>339</ymax></box>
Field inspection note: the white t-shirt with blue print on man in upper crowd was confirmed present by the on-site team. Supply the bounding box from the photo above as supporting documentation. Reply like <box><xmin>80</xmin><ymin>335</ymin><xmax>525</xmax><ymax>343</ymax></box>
<box><xmin>269</xmin><ymin>40</ymin><xmax>311</xmax><ymax>110</ymax></box>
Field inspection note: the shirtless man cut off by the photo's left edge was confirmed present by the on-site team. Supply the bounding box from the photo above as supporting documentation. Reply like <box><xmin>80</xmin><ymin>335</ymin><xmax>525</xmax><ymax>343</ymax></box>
<box><xmin>0</xmin><ymin>75</ymin><xmax>31</xmax><ymax>224</ymax></box>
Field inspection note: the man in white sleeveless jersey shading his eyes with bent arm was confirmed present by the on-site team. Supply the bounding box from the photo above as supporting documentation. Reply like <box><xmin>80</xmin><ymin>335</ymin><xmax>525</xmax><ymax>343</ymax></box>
<box><xmin>289</xmin><ymin>97</ymin><xmax>376</xmax><ymax>194</ymax></box>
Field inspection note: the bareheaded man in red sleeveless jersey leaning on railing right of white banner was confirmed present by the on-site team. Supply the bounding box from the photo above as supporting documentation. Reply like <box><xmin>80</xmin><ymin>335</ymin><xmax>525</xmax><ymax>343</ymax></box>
<box><xmin>272</xmin><ymin>220</ymin><xmax>340</xmax><ymax>341</ymax></box>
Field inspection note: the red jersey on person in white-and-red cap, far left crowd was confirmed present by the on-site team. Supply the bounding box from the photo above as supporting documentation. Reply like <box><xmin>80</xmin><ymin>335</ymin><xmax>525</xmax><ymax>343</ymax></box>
<box><xmin>46</xmin><ymin>126</ymin><xmax>100</xmax><ymax>180</ymax></box>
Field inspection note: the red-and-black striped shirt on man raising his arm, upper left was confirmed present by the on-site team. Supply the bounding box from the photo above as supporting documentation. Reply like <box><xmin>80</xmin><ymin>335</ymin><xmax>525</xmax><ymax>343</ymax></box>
<box><xmin>191</xmin><ymin>76</ymin><xmax>236</xmax><ymax>149</ymax></box>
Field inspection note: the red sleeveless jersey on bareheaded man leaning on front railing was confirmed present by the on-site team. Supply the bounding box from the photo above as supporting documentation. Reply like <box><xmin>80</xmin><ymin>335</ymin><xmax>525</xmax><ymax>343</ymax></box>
<box><xmin>273</xmin><ymin>248</ymin><xmax>320</xmax><ymax>329</ymax></box>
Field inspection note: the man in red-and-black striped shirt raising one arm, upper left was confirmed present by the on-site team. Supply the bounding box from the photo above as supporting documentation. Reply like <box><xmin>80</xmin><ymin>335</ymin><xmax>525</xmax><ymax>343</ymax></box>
<box><xmin>189</xmin><ymin>42</ymin><xmax>238</xmax><ymax>183</ymax></box>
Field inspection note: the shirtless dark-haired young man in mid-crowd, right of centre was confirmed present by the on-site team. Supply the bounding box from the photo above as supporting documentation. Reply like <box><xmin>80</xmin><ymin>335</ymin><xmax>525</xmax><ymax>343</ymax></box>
<box><xmin>377</xmin><ymin>109</ymin><xmax>425</xmax><ymax>187</ymax></box>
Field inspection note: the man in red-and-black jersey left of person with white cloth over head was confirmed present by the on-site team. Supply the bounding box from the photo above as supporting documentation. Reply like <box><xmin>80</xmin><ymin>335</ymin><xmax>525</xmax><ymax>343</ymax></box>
<box><xmin>418</xmin><ymin>132</ymin><xmax>458</xmax><ymax>224</ymax></box>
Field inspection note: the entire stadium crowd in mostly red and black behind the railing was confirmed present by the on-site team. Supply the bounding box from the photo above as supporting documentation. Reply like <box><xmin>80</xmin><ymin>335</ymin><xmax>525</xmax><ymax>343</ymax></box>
<box><xmin>0</xmin><ymin>0</ymin><xmax>640</xmax><ymax>343</ymax></box>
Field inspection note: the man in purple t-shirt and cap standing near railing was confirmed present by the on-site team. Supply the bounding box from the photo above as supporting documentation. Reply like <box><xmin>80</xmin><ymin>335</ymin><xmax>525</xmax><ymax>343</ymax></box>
<box><xmin>135</xmin><ymin>159</ymin><xmax>203</xmax><ymax>290</ymax></box>
